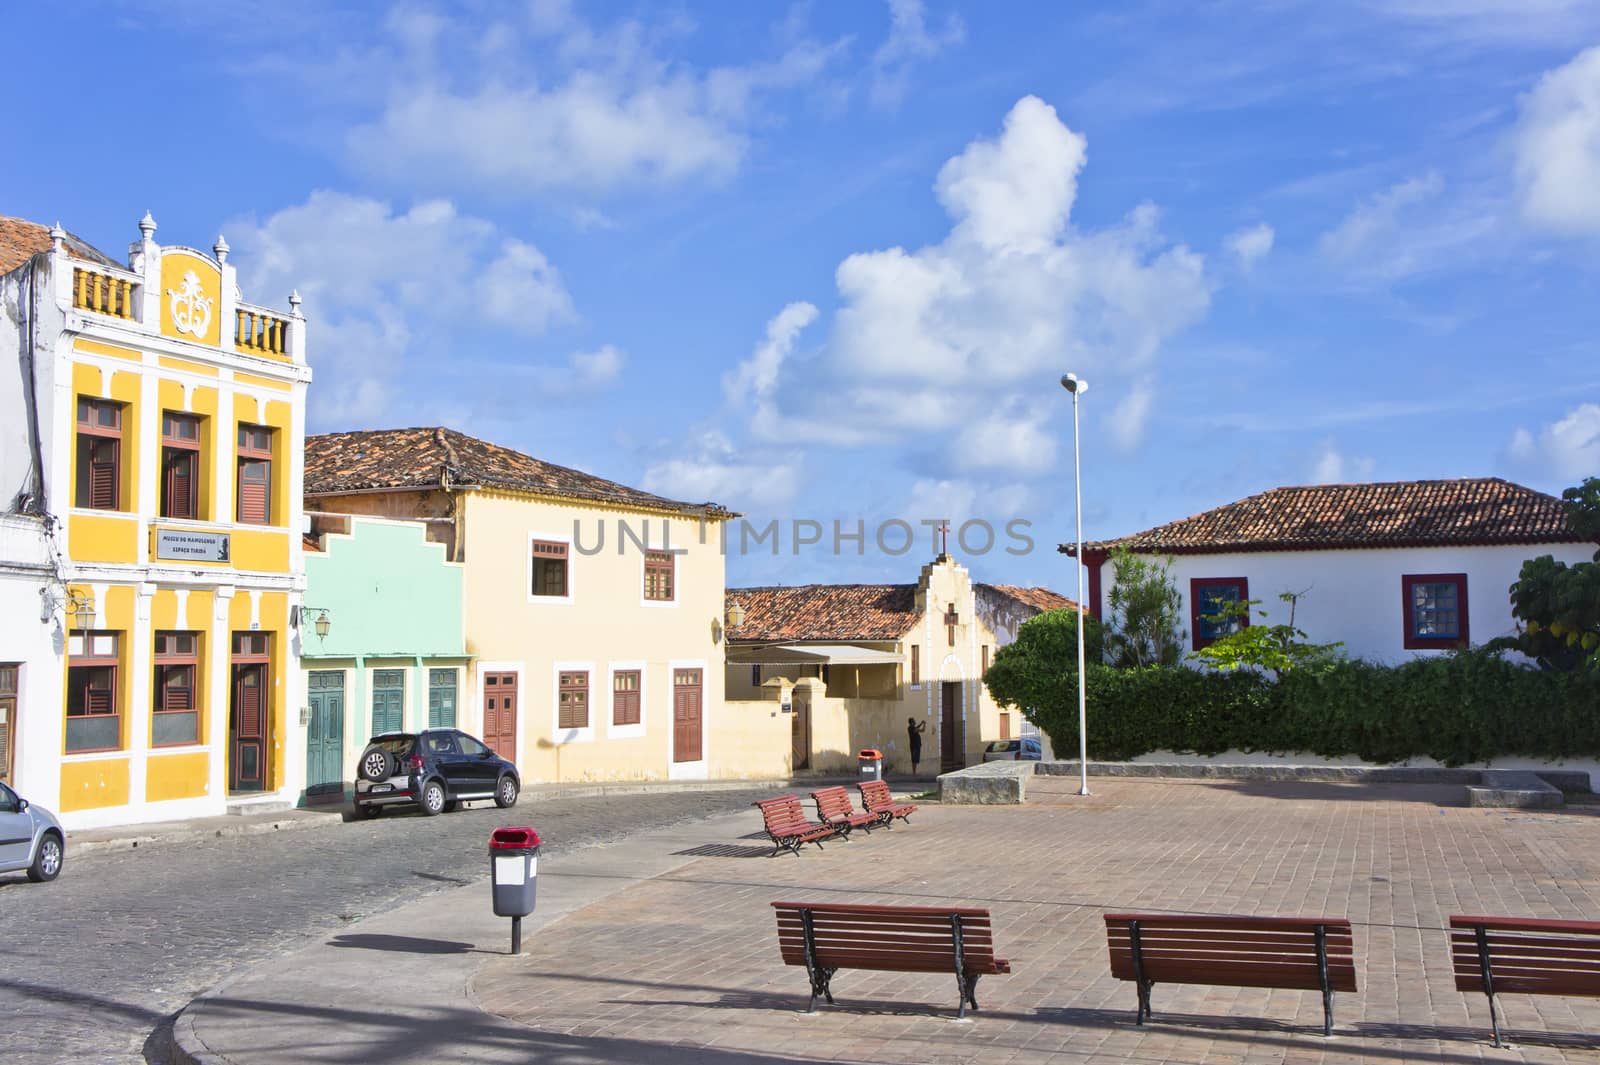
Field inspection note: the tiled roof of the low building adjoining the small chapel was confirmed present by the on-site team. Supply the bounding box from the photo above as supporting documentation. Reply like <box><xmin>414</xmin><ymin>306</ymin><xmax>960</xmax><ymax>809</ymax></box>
<box><xmin>725</xmin><ymin>584</ymin><xmax>920</xmax><ymax>643</ymax></box>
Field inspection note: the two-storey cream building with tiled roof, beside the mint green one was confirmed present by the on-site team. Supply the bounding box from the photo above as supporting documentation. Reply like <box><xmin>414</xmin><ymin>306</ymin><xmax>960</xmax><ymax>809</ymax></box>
<box><xmin>306</xmin><ymin>429</ymin><xmax>731</xmax><ymax>785</ymax></box>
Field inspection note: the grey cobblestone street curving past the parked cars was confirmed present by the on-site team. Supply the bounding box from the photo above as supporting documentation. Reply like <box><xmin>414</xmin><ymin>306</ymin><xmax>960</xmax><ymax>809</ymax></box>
<box><xmin>0</xmin><ymin>787</ymin><xmax>771</xmax><ymax>1065</ymax></box>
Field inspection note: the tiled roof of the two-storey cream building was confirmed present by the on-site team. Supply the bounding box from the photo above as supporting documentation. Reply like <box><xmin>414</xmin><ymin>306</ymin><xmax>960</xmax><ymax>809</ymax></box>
<box><xmin>306</xmin><ymin>429</ymin><xmax>730</xmax><ymax>517</ymax></box>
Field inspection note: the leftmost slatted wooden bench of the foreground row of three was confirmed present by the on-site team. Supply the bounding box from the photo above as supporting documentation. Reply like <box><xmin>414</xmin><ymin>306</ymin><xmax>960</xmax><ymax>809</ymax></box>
<box><xmin>773</xmin><ymin>902</ymin><xmax>1011</xmax><ymax>1017</ymax></box>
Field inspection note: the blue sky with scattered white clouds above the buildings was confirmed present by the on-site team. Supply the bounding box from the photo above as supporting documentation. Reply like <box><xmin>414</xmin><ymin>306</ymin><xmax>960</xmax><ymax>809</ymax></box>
<box><xmin>0</xmin><ymin>0</ymin><xmax>1600</xmax><ymax>595</ymax></box>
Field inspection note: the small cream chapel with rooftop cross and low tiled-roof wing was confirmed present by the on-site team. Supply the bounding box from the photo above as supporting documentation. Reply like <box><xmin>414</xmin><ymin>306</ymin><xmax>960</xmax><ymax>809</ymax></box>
<box><xmin>726</xmin><ymin>555</ymin><xmax>1022</xmax><ymax>776</ymax></box>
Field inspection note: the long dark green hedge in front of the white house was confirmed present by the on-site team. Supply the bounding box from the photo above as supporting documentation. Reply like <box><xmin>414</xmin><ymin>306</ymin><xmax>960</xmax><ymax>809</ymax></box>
<box><xmin>1030</xmin><ymin>651</ymin><xmax>1600</xmax><ymax>766</ymax></box>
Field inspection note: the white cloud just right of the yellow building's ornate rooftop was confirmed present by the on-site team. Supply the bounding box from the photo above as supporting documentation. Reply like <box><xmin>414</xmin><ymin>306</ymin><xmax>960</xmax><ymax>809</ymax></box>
<box><xmin>227</xmin><ymin>190</ymin><xmax>576</xmax><ymax>429</ymax></box>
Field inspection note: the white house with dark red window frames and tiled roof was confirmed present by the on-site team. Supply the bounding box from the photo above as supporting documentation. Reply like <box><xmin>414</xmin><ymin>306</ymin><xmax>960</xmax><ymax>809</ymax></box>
<box><xmin>1061</xmin><ymin>477</ymin><xmax>1595</xmax><ymax>664</ymax></box>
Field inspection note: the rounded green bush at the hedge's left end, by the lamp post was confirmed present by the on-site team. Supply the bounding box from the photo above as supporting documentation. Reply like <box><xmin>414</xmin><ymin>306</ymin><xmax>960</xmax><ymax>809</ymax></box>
<box><xmin>984</xmin><ymin>611</ymin><xmax>1106</xmax><ymax>737</ymax></box>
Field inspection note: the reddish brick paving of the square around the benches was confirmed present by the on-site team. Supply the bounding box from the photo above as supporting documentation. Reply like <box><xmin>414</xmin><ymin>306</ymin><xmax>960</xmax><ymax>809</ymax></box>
<box><xmin>470</xmin><ymin>777</ymin><xmax>1600</xmax><ymax>1065</ymax></box>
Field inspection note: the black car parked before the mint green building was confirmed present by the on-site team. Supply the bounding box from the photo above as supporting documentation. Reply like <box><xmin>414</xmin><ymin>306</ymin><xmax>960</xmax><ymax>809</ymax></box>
<box><xmin>355</xmin><ymin>729</ymin><xmax>522</xmax><ymax>817</ymax></box>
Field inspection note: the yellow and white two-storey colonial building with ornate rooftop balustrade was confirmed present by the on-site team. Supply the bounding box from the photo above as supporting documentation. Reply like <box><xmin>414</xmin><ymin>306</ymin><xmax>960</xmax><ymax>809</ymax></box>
<box><xmin>0</xmin><ymin>214</ymin><xmax>310</xmax><ymax>828</ymax></box>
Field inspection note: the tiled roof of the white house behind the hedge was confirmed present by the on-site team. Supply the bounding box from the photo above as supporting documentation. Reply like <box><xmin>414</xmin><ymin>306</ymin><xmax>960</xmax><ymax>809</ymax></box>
<box><xmin>1061</xmin><ymin>477</ymin><xmax>1578</xmax><ymax>555</ymax></box>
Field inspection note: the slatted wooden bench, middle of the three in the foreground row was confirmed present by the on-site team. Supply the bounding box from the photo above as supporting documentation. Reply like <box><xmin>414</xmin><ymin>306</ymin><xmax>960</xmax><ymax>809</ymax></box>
<box><xmin>1106</xmin><ymin>913</ymin><xmax>1355</xmax><ymax>1035</ymax></box>
